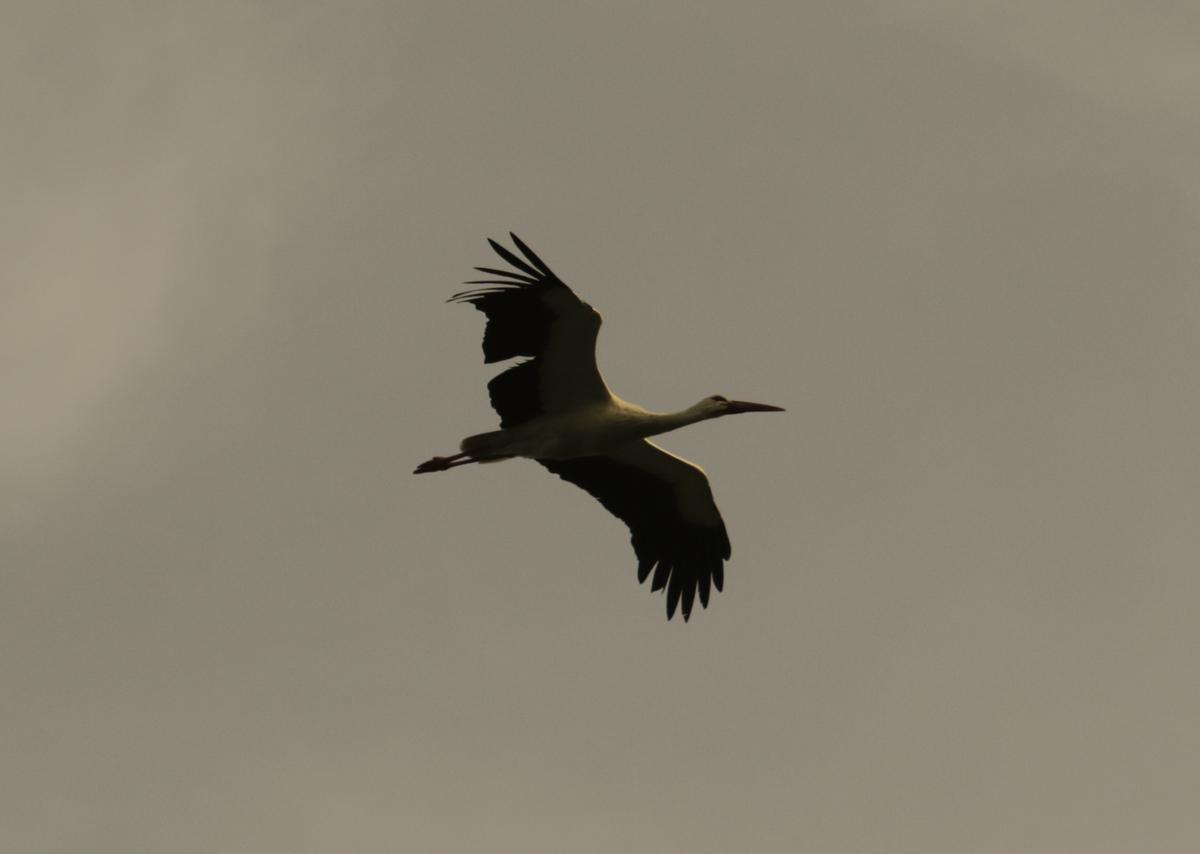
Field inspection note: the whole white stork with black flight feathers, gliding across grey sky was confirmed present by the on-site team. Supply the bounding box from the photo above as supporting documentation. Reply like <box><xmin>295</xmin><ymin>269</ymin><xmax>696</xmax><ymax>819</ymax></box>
<box><xmin>414</xmin><ymin>233</ymin><xmax>782</xmax><ymax>621</ymax></box>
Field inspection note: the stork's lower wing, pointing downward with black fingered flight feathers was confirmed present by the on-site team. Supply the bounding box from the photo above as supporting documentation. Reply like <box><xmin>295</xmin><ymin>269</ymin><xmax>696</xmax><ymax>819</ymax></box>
<box><xmin>538</xmin><ymin>439</ymin><xmax>731</xmax><ymax>620</ymax></box>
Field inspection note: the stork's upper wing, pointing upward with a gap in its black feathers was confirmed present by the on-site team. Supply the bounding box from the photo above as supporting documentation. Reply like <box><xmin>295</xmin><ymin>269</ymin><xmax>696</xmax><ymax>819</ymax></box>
<box><xmin>450</xmin><ymin>233</ymin><xmax>610</xmax><ymax>427</ymax></box>
